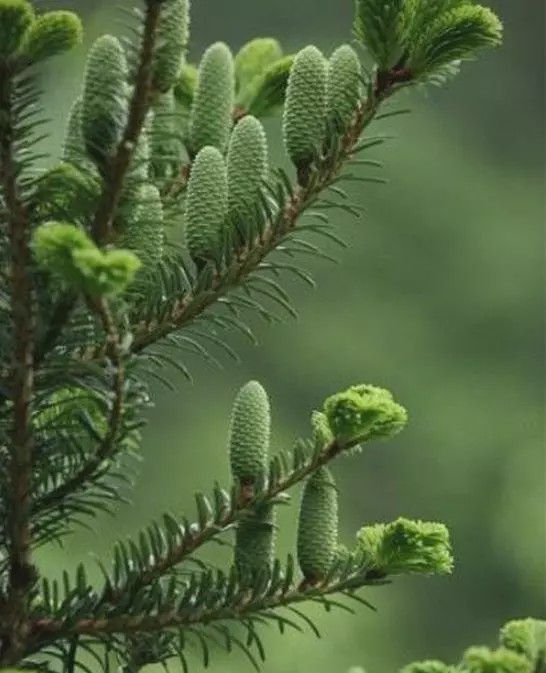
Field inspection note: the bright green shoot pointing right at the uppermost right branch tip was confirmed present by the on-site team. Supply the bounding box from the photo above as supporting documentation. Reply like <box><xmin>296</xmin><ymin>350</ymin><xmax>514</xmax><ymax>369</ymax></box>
<box><xmin>408</xmin><ymin>4</ymin><xmax>502</xmax><ymax>76</ymax></box>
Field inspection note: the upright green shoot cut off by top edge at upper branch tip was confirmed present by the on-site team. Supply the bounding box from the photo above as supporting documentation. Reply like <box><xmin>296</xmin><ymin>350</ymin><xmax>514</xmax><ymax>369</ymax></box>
<box><xmin>354</xmin><ymin>0</ymin><xmax>413</xmax><ymax>70</ymax></box>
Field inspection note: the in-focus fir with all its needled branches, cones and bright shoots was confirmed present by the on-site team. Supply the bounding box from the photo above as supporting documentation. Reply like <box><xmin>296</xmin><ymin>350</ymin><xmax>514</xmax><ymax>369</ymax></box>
<box><xmin>0</xmin><ymin>0</ymin><xmax>508</xmax><ymax>673</ymax></box>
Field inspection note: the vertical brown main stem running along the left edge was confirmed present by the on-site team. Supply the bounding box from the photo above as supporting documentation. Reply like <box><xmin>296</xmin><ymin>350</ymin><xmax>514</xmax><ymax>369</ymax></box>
<box><xmin>0</xmin><ymin>64</ymin><xmax>36</xmax><ymax>665</ymax></box>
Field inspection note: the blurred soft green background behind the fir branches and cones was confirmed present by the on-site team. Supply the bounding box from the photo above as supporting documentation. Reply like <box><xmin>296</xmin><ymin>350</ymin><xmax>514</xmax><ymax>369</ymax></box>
<box><xmin>36</xmin><ymin>0</ymin><xmax>546</xmax><ymax>673</ymax></box>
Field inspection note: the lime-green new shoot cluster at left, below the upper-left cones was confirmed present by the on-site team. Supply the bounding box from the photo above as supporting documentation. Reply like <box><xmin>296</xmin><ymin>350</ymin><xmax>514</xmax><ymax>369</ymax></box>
<box><xmin>32</xmin><ymin>222</ymin><xmax>140</xmax><ymax>297</ymax></box>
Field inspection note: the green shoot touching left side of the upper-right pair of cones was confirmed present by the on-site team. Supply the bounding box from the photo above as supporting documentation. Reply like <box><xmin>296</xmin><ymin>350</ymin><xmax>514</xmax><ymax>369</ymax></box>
<box><xmin>237</xmin><ymin>56</ymin><xmax>294</xmax><ymax>117</ymax></box>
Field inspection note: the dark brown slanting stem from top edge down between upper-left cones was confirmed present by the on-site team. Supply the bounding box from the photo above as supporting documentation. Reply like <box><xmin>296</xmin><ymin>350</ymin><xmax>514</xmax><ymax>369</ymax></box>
<box><xmin>92</xmin><ymin>0</ymin><xmax>162</xmax><ymax>243</ymax></box>
